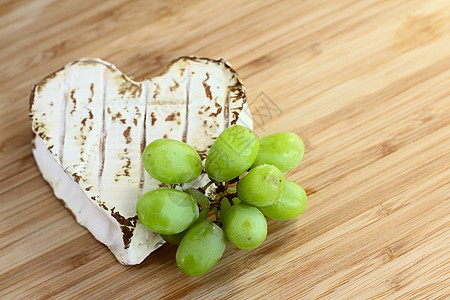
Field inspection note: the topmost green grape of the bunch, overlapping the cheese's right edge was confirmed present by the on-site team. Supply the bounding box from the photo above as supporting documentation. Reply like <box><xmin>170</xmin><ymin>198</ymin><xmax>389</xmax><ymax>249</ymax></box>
<box><xmin>205</xmin><ymin>125</ymin><xmax>259</xmax><ymax>182</ymax></box>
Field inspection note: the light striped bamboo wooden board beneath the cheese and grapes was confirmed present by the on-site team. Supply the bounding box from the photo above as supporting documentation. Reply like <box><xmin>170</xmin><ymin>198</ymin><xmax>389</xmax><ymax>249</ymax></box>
<box><xmin>0</xmin><ymin>0</ymin><xmax>450</xmax><ymax>299</ymax></box>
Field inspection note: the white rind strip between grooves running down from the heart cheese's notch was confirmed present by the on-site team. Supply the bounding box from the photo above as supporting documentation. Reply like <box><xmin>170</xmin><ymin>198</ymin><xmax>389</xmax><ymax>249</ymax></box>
<box><xmin>99</xmin><ymin>69</ymin><xmax>147</xmax><ymax>219</ymax></box>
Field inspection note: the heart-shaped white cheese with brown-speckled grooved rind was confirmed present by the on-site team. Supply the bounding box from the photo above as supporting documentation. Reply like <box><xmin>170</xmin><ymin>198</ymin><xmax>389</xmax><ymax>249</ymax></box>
<box><xmin>30</xmin><ymin>57</ymin><xmax>252</xmax><ymax>264</ymax></box>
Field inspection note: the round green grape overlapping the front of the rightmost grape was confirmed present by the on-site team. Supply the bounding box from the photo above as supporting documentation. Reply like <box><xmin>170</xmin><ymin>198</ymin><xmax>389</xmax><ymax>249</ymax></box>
<box><xmin>237</xmin><ymin>165</ymin><xmax>286</xmax><ymax>206</ymax></box>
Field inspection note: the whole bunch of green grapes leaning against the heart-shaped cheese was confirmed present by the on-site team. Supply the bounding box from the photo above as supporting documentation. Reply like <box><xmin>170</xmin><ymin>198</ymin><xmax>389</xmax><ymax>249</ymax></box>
<box><xmin>136</xmin><ymin>125</ymin><xmax>306</xmax><ymax>276</ymax></box>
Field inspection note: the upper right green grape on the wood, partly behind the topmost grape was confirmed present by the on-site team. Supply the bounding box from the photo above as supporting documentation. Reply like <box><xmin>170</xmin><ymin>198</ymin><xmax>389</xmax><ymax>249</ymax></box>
<box><xmin>252</xmin><ymin>132</ymin><xmax>305</xmax><ymax>173</ymax></box>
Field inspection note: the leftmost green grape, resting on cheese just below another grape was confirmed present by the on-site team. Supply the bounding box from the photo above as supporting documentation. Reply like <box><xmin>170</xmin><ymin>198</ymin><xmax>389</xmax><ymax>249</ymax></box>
<box><xmin>136</xmin><ymin>189</ymin><xmax>199</xmax><ymax>234</ymax></box>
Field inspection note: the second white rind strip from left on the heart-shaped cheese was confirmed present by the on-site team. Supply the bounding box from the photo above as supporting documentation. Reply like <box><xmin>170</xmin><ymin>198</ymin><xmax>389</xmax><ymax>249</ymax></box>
<box><xmin>62</xmin><ymin>63</ymin><xmax>108</xmax><ymax>200</ymax></box>
